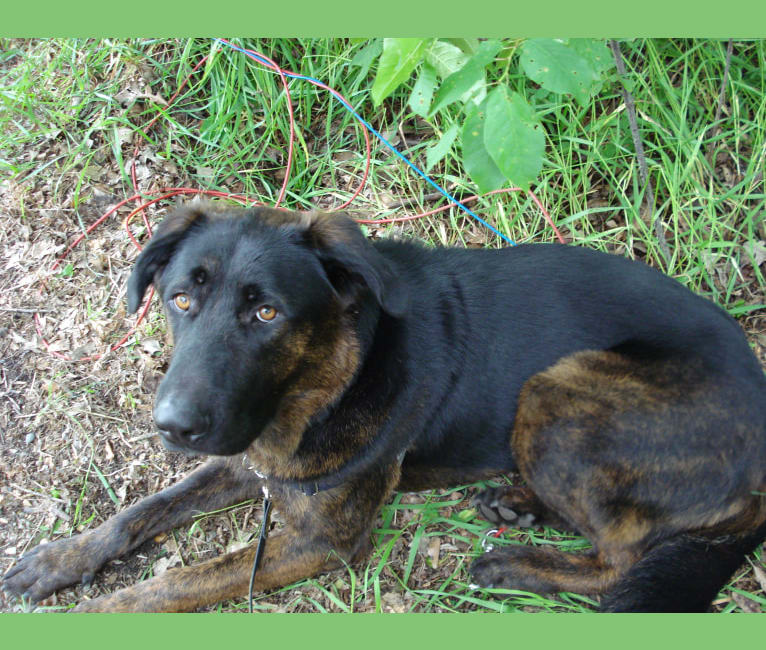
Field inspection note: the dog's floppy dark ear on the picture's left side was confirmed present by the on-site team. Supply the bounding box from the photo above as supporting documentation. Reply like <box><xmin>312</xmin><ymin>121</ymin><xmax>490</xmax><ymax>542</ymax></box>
<box><xmin>128</xmin><ymin>203</ymin><xmax>208</xmax><ymax>314</ymax></box>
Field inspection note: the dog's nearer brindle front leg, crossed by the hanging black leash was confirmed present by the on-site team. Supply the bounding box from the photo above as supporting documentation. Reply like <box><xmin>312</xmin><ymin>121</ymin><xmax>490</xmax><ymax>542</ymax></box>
<box><xmin>70</xmin><ymin>465</ymin><xmax>399</xmax><ymax>612</ymax></box>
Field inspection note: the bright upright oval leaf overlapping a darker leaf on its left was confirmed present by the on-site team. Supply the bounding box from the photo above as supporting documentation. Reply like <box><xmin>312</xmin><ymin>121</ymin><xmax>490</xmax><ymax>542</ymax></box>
<box><xmin>484</xmin><ymin>86</ymin><xmax>545</xmax><ymax>190</ymax></box>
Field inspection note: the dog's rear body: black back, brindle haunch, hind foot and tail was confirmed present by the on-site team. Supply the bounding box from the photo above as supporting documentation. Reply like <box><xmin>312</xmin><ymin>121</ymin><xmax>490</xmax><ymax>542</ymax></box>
<box><xmin>380</xmin><ymin>237</ymin><xmax>766</xmax><ymax>611</ymax></box>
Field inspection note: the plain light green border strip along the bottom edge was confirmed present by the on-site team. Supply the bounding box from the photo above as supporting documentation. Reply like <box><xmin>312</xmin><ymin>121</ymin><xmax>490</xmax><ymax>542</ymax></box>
<box><xmin>0</xmin><ymin>614</ymin><xmax>764</xmax><ymax>650</ymax></box>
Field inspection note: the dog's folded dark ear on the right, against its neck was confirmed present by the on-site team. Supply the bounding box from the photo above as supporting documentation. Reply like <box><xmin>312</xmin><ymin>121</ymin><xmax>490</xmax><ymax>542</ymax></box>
<box><xmin>301</xmin><ymin>212</ymin><xmax>409</xmax><ymax>317</ymax></box>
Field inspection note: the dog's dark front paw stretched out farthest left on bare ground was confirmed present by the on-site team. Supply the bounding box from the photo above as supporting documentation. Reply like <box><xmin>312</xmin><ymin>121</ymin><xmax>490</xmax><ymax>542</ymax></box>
<box><xmin>2</xmin><ymin>535</ymin><xmax>102</xmax><ymax>602</ymax></box>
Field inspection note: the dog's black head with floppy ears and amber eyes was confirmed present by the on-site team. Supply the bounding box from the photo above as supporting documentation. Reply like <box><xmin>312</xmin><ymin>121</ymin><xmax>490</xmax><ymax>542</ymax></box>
<box><xmin>128</xmin><ymin>204</ymin><xmax>407</xmax><ymax>455</ymax></box>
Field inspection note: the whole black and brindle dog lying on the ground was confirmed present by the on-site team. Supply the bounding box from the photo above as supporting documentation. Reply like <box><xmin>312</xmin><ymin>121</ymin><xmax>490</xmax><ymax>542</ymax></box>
<box><xmin>4</xmin><ymin>204</ymin><xmax>766</xmax><ymax>611</ymax></box>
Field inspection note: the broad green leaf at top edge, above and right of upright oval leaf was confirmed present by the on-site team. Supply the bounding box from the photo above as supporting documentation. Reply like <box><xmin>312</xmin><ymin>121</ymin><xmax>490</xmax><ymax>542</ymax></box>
<box><xmin>520</xmin><ymin>38</ymin><xmax>600</xmax><ymax>106</ymax></box>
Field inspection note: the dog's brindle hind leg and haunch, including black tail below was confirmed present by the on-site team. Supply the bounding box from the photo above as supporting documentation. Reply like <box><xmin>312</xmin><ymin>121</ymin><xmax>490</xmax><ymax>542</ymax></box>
<box><xmin>472</xmin><ymin>351</ymin><xmax>766</xmax><ymax>611</ymax></box>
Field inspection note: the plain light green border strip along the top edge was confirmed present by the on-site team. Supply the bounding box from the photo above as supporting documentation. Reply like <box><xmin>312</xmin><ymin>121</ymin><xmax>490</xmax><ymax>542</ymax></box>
<box><xmin>0</xmin><ymin>0</ymin><xmax>766</xmax><ymax>38</ymax></box>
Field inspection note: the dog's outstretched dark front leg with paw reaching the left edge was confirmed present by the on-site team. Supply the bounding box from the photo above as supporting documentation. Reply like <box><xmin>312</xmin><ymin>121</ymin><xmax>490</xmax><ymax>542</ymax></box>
<box><xmin>3</xmin><ymin>458</ymin><xmax>261</xmax><ymax>601</ymax></box>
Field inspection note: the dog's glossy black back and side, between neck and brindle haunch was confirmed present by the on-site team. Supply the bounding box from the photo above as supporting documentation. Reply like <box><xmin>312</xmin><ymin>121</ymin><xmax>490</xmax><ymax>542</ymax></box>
<box><xmin>390</xmin><ymin>242</ymin><xmax>766</xmax><ymax>470</ymax></box>
